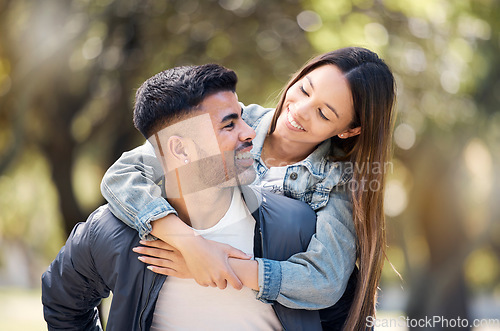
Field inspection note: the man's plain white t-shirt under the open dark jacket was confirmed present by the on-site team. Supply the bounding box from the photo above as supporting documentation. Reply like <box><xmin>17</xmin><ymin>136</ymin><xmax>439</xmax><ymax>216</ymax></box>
<box><xmin>151</xmin><ymin>188</ymin><xmax>282</xmax><ymax>331</ymax></box>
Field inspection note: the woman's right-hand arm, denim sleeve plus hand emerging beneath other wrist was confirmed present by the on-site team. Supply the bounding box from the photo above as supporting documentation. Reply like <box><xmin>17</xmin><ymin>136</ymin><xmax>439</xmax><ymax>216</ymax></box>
<box><xmin>141</xmin><ymin>196</ymin><xmax>356</xmax><ymax>309</ymax></box>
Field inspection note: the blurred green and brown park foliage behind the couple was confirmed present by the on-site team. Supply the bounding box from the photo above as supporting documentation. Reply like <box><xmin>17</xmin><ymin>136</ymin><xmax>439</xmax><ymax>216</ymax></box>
<box><xmin>0</xmin><ymin>0</ymin><xmax>500</xmax><ymax>330</ymax></box>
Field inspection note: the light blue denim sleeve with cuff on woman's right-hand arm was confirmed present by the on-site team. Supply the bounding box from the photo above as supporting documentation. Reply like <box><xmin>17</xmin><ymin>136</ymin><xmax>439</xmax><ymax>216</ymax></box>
<box><xmin>257</xmin><ymin>188</ymin><xmax>356</xmax><ymax>309</ymax></box>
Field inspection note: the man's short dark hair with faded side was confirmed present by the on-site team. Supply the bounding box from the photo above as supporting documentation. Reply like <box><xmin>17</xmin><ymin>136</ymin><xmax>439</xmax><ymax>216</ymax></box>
<box><xmin>134</xmin><ymin>64</ymin><xmax>238</xmax><ymax>138</ymax></box>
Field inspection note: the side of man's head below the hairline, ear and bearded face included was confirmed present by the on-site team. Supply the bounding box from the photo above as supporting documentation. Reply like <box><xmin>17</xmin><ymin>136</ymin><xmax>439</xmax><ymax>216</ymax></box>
<box><xmin>149</xmin><ymin>92</ymin><xmax>255</xmax><ymax>198</ymax></box>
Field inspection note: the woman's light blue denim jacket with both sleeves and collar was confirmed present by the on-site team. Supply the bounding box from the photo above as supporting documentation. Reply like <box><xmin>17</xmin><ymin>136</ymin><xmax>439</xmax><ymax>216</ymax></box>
<box><xmin>101</xmin><ymin>105</ymin><xmax>356</xmax><ymax>309</ymax></box>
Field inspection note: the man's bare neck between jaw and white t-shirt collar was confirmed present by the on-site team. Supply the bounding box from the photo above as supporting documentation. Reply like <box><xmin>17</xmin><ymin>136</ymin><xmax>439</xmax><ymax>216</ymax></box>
<box><xmin>167</xmin><ymin>188</ymin><xmax>233</xmax><ymax>230</ymax></box>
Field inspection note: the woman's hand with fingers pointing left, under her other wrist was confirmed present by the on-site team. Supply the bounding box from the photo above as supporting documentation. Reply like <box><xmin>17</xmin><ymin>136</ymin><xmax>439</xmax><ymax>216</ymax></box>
<box><xmin>132</xmin><ymin>240</ymin><xmax>193</xmax><ymax>278</ymax></box>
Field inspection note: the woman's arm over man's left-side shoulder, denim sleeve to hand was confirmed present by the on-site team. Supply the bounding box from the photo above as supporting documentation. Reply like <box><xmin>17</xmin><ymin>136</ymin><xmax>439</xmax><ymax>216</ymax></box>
<box><xmin>101</xmin><ymin>142</ymin><xmax>249</xmax><ymax>288</ymax></box>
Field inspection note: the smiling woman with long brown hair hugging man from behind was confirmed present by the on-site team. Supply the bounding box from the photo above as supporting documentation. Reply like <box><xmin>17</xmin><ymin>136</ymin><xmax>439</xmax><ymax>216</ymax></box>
<box><xmin>102</xmin><ymin>47</ymin><xmax>395</xmax><ymax>330</ymax></box>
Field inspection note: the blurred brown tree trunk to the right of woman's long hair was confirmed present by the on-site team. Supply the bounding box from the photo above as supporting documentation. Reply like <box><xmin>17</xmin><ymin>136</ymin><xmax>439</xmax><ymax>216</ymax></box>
<box><xmin>407</xmin><ymin>134</ymin><xmax>470</xmax><ymax>330</ymax></box>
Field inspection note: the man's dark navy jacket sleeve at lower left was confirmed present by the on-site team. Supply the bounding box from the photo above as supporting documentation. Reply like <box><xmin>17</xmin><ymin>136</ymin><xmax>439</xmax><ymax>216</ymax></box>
<box><xmin>42</xmin><ymin>209</ymin><xmax>110</xmax><ymax>330</ymax></box>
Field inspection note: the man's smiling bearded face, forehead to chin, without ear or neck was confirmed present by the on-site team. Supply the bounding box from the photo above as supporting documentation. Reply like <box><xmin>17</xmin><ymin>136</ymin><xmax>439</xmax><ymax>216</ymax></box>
<box><xmin>195</xmin><ymin>91</ymin><xmax>255</xmax><ymax>186</ymax></box>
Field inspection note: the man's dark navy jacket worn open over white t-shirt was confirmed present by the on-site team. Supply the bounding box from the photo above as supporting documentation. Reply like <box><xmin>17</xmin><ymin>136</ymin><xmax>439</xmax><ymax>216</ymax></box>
<box><xmin>42</xmin><ymin>187</ymin><xmax>356</xmax><ymax>331</ymax></box>
